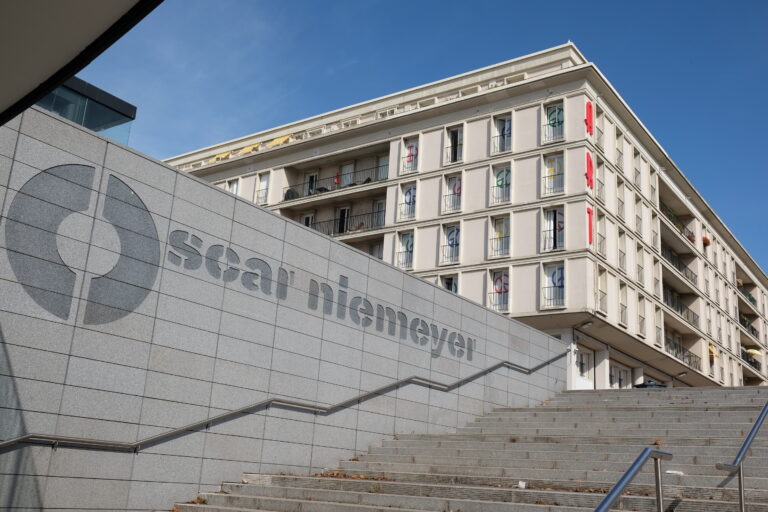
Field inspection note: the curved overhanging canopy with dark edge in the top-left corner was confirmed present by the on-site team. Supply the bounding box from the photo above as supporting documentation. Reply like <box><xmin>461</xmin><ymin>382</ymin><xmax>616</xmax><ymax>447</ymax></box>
<box><xmin>0</xmin><ymin>0</ymin><xmax>163</xmax><ymax>126</ymax></box>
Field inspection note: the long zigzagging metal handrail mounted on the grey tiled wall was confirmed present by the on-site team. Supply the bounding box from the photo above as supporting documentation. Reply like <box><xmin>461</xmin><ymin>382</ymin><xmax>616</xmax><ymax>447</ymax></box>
<box><xmin>0</xmin><ymin>350</ymin><xmax>569</xmax><ymax>452</ymax></box>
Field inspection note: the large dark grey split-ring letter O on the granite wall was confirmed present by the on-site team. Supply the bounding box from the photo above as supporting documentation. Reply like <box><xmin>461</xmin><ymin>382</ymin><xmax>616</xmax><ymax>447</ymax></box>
<box><xmin>5</xmin><ymin>164</ymin><xmax>160</xmax><ymax>324</ymax></box>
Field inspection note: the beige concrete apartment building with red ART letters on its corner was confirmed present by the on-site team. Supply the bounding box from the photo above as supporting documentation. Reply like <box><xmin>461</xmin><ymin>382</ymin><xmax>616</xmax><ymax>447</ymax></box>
<box><xmin>168</xmin><ymin>43</ymin><xmax>768</xmax><ymax>389</ymax></box>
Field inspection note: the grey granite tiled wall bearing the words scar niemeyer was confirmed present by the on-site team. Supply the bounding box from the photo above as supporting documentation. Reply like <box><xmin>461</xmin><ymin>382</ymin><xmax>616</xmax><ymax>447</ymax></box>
<box><xmin>0</xmin><ymin>109</ymin><xmax>567</xmax><ymax>510</ymax></box>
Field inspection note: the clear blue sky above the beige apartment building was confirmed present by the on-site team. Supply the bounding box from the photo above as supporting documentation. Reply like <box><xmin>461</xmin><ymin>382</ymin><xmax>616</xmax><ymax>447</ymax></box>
<box><xmin>78</xmin><ymin>0</ymin><xmax>768</xmax><ymax>269</ymax></box>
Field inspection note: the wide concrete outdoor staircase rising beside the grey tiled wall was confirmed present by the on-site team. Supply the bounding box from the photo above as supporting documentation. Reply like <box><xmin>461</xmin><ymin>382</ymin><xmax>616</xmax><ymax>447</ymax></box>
<box><xmin>176</xmin><ymin>388</ymin><xmax>768</xmax><ymax>512</ymax></box>
